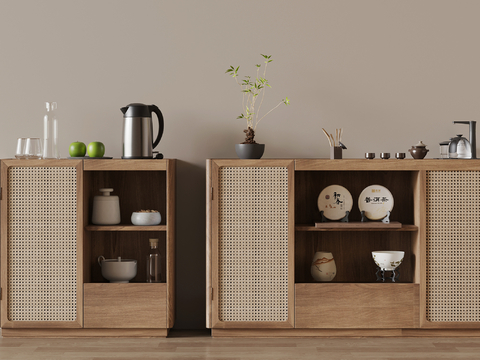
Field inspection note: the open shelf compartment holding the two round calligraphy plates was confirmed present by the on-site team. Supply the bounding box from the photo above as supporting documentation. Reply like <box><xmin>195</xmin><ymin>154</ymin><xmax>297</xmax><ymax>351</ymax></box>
<box><xmin>295</xmin><ymin>170</ymin><xmax>422</xmax><ymax>285</ymax></box>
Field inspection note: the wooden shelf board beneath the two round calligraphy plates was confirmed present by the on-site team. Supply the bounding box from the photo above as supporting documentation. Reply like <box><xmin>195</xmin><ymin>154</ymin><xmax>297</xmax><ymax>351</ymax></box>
<box><xmin>295</xmin><ymin>221</ymin><xmax>418</xmax><ymax>231</ymax></box>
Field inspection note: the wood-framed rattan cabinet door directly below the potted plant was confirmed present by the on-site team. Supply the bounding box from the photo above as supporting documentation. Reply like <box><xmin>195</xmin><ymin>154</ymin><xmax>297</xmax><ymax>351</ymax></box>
<box><xmin>207</xmin><ymin>160</ymin><xmax>294</xmax><ymax>328</ymax></box>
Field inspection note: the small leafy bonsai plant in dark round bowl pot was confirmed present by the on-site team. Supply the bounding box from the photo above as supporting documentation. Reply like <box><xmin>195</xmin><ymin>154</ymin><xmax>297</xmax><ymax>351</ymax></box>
<box><xmin>225</xmin><ymin>54</ymin><xmax>289</xmax><ymax>159</ymax></box>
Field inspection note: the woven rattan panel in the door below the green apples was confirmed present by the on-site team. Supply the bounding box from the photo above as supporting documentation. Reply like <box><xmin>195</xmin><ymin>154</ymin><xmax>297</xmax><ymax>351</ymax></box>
<box><xmin>7</xmin><ymin>167</ymin><xmax>77</xmax><ymax>321</ymax></box>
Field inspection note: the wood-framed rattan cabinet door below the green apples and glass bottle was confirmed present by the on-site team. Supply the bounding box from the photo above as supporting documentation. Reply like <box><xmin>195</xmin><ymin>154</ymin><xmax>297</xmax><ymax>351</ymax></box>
<box><xmin>1</xmin><ymin>160</ymin><xmax>83</xmax><ymax>328</ymax></box>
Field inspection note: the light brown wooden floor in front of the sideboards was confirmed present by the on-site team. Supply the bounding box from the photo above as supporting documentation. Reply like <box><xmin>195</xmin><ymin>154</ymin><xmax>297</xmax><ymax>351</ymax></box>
<box><xmin>0</xmin><ymin>330</ymin><xmax>480</xmax><ymax>360</ymax></box>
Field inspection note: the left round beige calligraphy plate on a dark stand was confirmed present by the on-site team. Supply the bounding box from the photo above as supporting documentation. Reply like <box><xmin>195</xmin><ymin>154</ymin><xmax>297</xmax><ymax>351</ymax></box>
<box><xmin>317</xmin><ymin>185</ymin><xmax>353</xmax><ymax>220</ymax></box>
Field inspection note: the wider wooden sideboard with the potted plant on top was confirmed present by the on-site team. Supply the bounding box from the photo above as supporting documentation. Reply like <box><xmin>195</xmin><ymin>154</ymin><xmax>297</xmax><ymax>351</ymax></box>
<box><xmin>206</xmin><ymin>159</ymin><xmax>480</xmax><ymax>336</ymax></box>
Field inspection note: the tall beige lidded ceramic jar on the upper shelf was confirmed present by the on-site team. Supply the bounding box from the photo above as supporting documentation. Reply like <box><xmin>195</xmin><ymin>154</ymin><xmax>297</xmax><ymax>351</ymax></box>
<box><xmin>92</xmin><ymin>188</ymin><xmax>121</xmax><ymax>225</ymax></box>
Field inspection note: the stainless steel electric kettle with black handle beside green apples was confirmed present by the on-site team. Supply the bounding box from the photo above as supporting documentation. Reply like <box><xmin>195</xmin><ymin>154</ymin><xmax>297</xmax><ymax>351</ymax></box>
<box><xmin>120</xmin><ymin>103</ymin><xmax>163</xmax><ymax>159</ymax></box>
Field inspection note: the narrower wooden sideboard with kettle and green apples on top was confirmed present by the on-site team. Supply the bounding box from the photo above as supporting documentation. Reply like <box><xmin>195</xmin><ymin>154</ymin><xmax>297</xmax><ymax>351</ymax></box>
<box><xmin>1</xmin><ymin>159</ymin><xmax>175</xmax><ymax>337</ymax></box>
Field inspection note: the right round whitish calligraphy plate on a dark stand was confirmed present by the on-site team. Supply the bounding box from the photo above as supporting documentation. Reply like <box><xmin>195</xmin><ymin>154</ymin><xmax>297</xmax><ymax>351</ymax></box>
<box><xmin>358</xmin><ymin>185</ymin><xmax>393</xmax><ymax>220</ymax></box>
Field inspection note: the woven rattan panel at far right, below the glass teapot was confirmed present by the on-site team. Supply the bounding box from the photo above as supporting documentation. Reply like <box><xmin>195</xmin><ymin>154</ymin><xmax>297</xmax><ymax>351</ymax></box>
<box><xmin>426</xmin><ymin>171</ymin><xmax>480</xmax><ymax>322</ymax></box>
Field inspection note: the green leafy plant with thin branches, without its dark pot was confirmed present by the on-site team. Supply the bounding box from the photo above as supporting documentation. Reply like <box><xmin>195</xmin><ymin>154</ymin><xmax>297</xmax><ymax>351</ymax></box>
<box><xmin>225</xmin><ymin>54</ymin><xmax>290</xmax><ymax>144</ymax></box>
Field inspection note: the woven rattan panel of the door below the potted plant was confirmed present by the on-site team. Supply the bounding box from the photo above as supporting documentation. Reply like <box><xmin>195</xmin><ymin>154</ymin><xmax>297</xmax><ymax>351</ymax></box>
<box><xmin>218</xmin><ymin>167</ymin><xmax>288</xmax><ymax>321</ymax></box>
